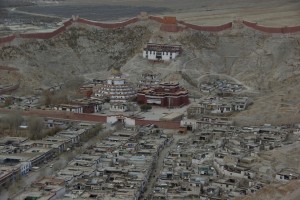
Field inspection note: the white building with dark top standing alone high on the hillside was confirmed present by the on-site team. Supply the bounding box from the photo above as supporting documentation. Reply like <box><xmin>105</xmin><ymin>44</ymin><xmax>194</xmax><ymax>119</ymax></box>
<box><xmin>143</xmin><ymin>43</ymin><xmax>182</xmax><ymax>61</ymax></box>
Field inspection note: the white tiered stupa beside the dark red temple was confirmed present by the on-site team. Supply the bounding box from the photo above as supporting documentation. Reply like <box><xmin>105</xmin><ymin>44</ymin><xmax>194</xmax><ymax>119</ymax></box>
<box><xmin>95</xmin><ymin>69</ymin><xmax>136</xmax><ymax>103</ymax></box>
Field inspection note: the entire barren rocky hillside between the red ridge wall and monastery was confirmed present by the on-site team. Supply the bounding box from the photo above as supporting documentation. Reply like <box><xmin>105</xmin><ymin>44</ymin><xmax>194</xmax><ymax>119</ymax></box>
<box><xmin>0</xmin><ymin>21</ymin><xmax>300</xmax><ymax>123</ymax></box>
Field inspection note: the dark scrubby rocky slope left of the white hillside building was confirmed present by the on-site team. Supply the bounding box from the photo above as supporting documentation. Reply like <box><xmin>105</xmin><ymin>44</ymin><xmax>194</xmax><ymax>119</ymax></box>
<box><xmin>0</xmin><ymin>26</ymin><xmax>150</xmax><ymax>94</ymax></box>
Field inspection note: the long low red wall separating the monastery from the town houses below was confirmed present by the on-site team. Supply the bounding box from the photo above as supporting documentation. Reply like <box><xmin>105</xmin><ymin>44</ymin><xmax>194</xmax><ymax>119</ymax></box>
<box><xmin>0</xmin><ymin>108</ymin><xmax>180</xmax><ymax>129</ymax></box>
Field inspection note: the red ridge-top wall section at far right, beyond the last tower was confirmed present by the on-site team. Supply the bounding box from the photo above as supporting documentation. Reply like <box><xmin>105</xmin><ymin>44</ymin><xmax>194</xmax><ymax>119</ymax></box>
<box><xmin>243</xmin><ymin>21</ymin><xmax>300</xmax><ymax>34</ymax></box>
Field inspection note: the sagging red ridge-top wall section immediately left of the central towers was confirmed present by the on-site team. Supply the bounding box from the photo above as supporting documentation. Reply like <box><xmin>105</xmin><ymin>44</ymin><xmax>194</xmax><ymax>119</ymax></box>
<box><xmin>77</xmin><ymin>17</ymin><xmax>138</xmax><ymax>29</ymax></box>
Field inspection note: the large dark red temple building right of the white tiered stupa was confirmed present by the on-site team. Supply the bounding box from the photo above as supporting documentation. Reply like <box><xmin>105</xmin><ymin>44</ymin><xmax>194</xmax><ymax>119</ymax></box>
<box><xmin>137</xmin><ymin>82</ymin><xmax>189</xmax><ymax>108</ymax></box>
